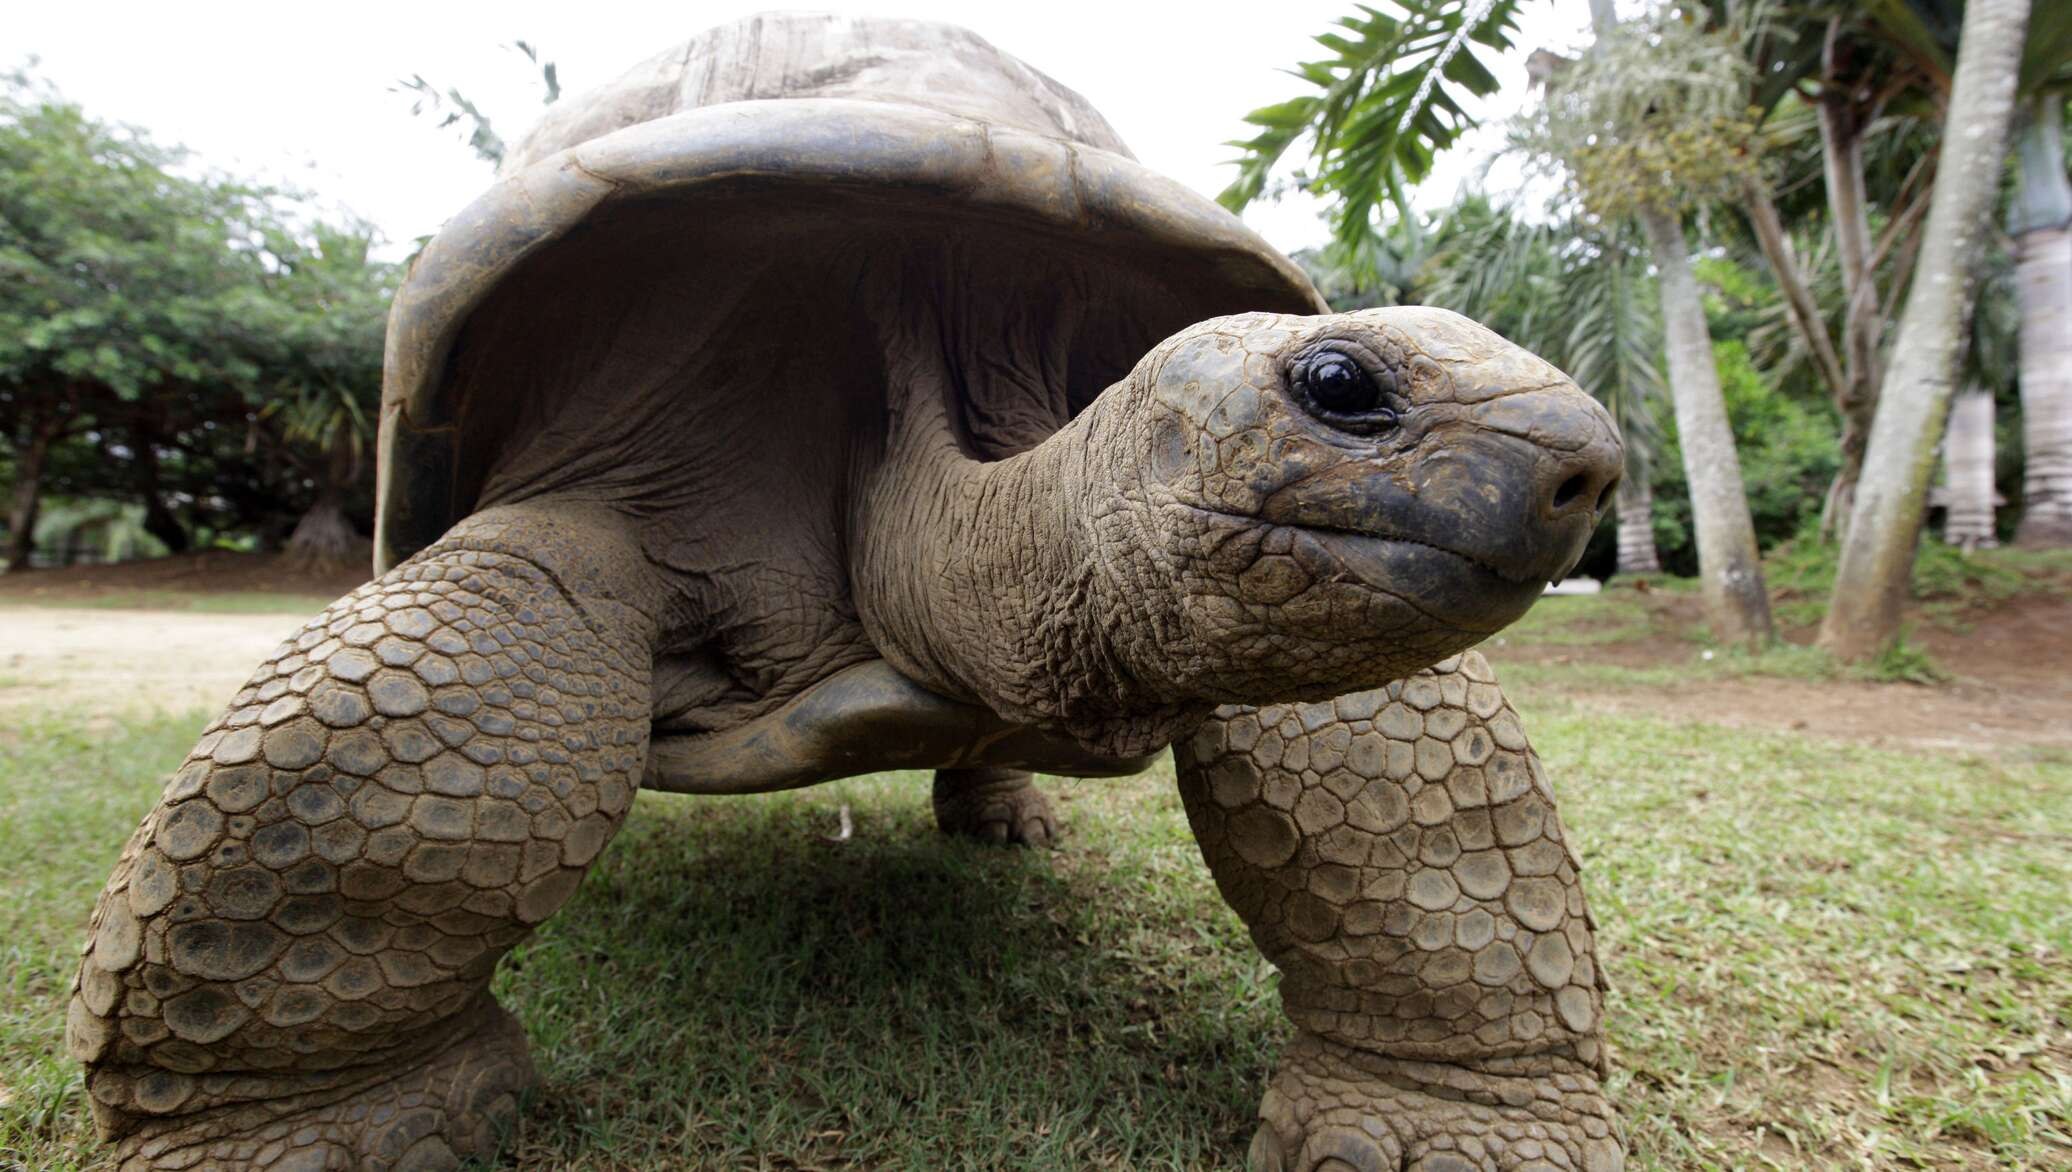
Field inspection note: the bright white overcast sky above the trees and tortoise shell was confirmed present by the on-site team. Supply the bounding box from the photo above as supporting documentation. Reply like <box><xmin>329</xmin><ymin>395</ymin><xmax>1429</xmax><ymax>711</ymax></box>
<box><xmin>0</xmin><ymin>0</ymin><xmax>1589</xmax><ymax>255</ymax></box>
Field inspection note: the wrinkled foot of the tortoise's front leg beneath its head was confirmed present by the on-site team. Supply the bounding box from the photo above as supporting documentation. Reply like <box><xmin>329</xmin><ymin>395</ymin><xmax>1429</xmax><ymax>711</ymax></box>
<box><xmin>1249</xmin><ymin>1033</ymin><xmax>1624</xmax><ymax>1172</ymax></box>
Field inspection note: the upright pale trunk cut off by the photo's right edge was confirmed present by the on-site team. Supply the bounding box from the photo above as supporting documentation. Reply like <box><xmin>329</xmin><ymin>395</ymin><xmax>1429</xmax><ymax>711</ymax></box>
<box><xmin>2012</xmin><ymin>95</ymin><xmax>2072</xmax><ymax>547</ymax></box>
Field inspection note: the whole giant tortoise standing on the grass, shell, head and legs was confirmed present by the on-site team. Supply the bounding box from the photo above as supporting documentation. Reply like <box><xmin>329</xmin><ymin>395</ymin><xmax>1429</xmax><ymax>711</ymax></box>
<box><xmin>66</xmin><ymin>17</ymin><xmax>1620</xmax><ymax>1172</ymax></box>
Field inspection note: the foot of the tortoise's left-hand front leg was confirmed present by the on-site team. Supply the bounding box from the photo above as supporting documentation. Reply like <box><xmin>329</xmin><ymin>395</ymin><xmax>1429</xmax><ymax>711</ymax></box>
<box><xmin>118</xmin><ymin>996</ymin><xmax>537</xmax><ymax>1172</ymax></box>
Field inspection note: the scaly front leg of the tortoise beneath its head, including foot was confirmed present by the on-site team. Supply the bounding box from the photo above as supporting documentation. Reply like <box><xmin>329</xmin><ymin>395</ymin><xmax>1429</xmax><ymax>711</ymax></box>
<box><xmin>1175</xmin><ymin>652</ymin><xmax>1624</xmax><ymax>1172</ymax></box>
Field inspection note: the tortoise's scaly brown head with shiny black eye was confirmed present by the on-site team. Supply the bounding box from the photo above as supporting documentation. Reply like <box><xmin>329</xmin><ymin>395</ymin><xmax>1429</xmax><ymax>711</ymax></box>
<box><xmin>1094</xmin><ymin>309</ymin><xmax>1620</xmax><ymax>700</ymax></box>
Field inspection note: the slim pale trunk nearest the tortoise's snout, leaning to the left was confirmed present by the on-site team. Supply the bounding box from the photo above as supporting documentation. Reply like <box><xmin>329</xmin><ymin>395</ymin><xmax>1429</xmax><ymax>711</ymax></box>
<box><xmin>1641</xmin><ymin>209</ymin><xmax>1776</xmax><ymax>646</ymax></box>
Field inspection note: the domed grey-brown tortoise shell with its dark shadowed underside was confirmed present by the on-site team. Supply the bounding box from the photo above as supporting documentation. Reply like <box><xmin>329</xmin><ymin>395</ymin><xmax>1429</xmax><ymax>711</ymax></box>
<box><xmin>375</xmin><ymin>14</ymin><xmax>1322</xmax><ymax>572</ymax></box>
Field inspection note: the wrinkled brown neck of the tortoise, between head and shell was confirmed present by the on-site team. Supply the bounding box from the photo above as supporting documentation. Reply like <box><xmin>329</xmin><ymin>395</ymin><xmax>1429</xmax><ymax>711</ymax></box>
<box><xmin>852</xmin><ymin>367</ymin><xmax>1212</xmax><ymax>756</ymax></box>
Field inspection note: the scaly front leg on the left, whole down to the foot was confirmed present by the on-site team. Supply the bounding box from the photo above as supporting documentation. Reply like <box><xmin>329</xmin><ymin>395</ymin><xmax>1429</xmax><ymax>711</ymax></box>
<box><xmin>66</xmin><ymin>513</ymin><xmax>653</xmax><ymax>1170</ymax></box>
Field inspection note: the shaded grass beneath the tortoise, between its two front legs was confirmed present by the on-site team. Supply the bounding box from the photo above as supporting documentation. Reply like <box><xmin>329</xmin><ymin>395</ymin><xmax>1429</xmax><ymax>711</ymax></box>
<box><xmin>497</xmin><ymin>797</ymin><xmax>1283</xmax><ymax>1168</ymax></box>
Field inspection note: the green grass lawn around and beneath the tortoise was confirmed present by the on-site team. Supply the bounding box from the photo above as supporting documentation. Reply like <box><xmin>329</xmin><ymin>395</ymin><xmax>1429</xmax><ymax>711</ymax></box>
<box><xmin>0</xmin><ymin>685</ymin><xmax>2072</xmax><ymax>1170</ymax></box>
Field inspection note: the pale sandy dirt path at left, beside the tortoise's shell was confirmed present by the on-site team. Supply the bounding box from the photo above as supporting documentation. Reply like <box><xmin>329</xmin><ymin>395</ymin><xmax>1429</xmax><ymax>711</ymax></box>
<box><xmin>0</xmin><ymin>607</ymin><xmax>314</xmax><ymax>725</ymax></box>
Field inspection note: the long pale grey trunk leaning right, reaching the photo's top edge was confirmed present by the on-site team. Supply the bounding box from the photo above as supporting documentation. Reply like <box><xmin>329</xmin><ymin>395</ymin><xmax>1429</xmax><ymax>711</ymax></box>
<box><xmin>1819</xmin><ymin>0</ymin><xmax>2028</xmax><ymax>661</ymax></box>
